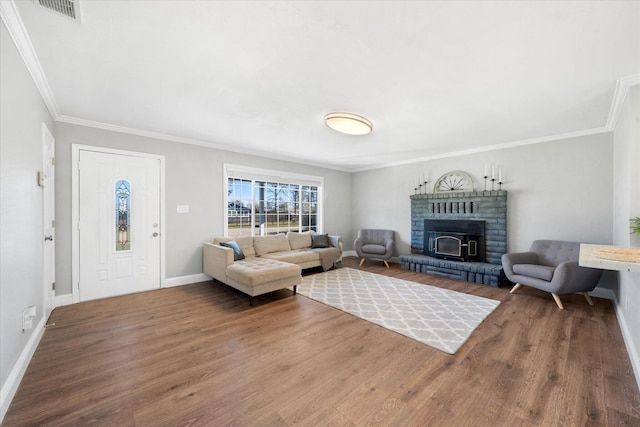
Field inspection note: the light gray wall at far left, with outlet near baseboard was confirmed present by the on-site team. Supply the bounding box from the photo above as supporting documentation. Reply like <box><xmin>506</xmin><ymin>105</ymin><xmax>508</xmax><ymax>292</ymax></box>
<box><xmin>0</xmin><ymin>23</ymin><xmax>52</xmax><ymax>402</ymax></box>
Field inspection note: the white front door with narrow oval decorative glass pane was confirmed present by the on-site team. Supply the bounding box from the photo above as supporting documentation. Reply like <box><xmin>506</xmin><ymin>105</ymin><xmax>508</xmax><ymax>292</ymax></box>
<box><xmin>78</xmin><ymin>149</ymin><xmax>161</xmax><ymax>301</ymax></box>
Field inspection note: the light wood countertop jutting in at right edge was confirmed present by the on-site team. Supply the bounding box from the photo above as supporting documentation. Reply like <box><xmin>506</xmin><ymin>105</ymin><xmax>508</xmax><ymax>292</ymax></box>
<box><xmin>578</xmin><ymin>243</ymin><xmax>640</xmax><ymax>272</ymax></box>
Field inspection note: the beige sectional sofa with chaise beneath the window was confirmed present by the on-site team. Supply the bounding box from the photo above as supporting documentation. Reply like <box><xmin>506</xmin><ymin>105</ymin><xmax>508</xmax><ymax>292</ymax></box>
<box><xmin>202</xmin><ymin>232</ymin><xmax>342</xmax><ymax>306</ymax></box>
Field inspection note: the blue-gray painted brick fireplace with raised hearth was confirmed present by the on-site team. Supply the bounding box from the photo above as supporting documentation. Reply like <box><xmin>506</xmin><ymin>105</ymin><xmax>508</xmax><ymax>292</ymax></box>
<box><xmin>400</xmin><ymin>191</ymin><xmax>507</xmax><ymax>286</ymax></box>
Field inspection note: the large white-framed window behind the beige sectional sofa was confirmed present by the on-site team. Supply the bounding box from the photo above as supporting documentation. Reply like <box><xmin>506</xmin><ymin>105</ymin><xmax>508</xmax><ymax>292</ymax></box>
<box><xmin>225</xmin><ymin>165</ymin><xmax>322</xmax><ymax>237</ymax></box>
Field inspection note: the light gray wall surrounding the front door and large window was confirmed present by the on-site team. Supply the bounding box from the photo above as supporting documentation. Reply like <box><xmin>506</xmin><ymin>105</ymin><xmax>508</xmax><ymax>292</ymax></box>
<box><xmin>54</xmin><ymin>122</ymin><xmax>351</xmax><ymax>295</ymax></box>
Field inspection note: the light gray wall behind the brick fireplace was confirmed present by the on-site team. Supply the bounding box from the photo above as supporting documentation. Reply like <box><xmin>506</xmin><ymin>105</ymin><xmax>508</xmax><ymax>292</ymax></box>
<box><xmin>352</xmin><ymin>133</ymin><xmax>613</xmax><ymax>255</ymax></box>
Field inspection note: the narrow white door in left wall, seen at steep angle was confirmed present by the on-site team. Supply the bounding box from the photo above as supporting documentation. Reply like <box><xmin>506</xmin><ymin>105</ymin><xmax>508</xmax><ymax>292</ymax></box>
<box><xmin>40</xmin><ymin>123</ymin><xmax>56</xmax><ymax>319</ymax></box>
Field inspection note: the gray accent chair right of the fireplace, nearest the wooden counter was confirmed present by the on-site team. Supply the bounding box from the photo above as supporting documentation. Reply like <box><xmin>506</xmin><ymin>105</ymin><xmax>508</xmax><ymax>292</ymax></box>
<box><xmin>502</xmin><ymin>240</ymin><xmax>602</xmax><ymax>310</ymax></box>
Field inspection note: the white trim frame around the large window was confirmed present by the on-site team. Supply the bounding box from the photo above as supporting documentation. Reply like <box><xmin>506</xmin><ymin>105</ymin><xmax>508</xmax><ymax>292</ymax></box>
<box><xmin>222</xmin><ymin>163</ymin><xmax>324</xmax><ymax>236</ymax></box>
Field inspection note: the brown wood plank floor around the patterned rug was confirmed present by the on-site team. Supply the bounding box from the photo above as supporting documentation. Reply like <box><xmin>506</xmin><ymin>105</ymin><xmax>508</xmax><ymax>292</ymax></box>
<box><xmin>3</xmin><ymin>258</ymin><xmax>640</xmax><ymax>426</ymax></box>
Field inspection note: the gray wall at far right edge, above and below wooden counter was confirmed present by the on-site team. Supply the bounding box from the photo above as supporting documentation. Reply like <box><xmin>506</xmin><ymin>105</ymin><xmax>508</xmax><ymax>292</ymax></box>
<box><xmin>613</xmin><ymin>86</ymin><xmax>640</xmax><ymax>384</ymax></box>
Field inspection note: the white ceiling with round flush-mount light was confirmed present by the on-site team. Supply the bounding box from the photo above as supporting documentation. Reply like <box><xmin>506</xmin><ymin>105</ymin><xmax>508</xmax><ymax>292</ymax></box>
<box><xmin>2</xmin><ymin>0</ymin><xmax>640</xmax><ymax>171</ymax></box>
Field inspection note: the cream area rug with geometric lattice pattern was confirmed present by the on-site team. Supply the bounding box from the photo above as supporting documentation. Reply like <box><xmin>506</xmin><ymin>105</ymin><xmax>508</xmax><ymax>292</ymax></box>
<box><xmin>298</xmin><ymin>268</ymin><xmax>500</xmax><ymax>354</ymax></box>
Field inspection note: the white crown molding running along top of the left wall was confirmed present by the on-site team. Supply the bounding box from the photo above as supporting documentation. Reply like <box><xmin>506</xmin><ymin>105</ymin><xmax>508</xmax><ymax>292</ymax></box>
<box><xmin>0</xmin><ymin>0</ymin><xmax>60</xmax><ymax>119</ymax></box>
